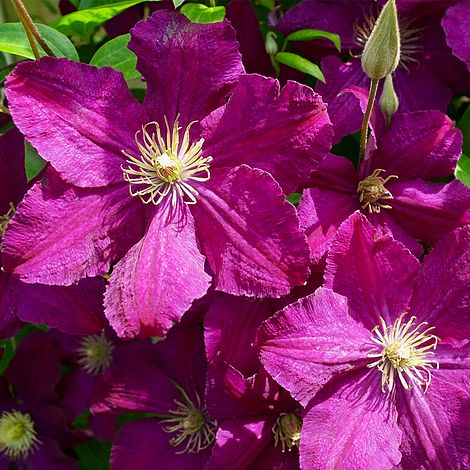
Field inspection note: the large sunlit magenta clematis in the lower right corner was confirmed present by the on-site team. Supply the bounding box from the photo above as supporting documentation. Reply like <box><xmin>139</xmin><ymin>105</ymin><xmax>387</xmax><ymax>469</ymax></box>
<box><xmin>257</xmin><ymin>213</ymin><xmax>470</xmax><ymax>470</ymax></box>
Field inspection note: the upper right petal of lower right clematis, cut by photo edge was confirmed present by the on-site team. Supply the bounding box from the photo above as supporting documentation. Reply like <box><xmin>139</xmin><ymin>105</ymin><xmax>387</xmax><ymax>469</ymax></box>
<box><xmin>410</xmin><ymin>226</ymin><xmax>470</xmax><ymax>340</ymax></box>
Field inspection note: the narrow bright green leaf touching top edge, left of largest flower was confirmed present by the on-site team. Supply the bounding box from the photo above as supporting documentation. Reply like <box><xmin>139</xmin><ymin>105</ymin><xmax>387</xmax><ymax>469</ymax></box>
<box><xmin>51</xmin><ymin>0</ymin><xmax>160</xmax><ymax>39</ymax></box>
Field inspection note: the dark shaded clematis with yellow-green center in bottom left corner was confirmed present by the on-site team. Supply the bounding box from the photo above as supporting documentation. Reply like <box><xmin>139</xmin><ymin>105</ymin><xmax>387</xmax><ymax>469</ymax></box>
<box><xmin>0</xmin><ymin>333</ymin><xmax>86</xmax><ymax>470</ymax></box>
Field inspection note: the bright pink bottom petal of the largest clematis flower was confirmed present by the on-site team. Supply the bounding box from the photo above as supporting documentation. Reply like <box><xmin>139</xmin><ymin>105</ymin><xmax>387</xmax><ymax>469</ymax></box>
<box><xmin>105</xmin><ymin>208</ymin><xmax>210</xmax><ymax>338</ymax></box>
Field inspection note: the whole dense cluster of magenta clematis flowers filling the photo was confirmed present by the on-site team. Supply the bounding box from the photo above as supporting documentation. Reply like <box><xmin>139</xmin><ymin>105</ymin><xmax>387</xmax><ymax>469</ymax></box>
<box><xmin>0</xmin><ymin>0</ymin><xmax>470</xmax><ymax>470</ymax></box>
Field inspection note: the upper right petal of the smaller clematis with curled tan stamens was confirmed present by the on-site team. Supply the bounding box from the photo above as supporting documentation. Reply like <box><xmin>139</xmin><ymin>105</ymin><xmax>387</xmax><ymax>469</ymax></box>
<box><xmin>371</xmin><ymin>111</ymin><xmax>462</xmax><ymax>181</ymax></box>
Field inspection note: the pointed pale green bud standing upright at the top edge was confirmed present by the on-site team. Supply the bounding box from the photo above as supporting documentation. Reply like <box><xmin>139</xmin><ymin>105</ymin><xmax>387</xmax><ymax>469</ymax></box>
<box><xmin>361</xmin><ymin>0</ymin><xmax>400</xmax><ymax>80</ymax></box>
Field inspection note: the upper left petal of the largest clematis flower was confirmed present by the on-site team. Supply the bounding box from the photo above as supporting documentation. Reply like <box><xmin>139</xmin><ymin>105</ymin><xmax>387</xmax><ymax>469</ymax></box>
<box><xmin>6</xmin><ymin>57</ymin><xmax>147</xmax><ymax>187</ymax></box>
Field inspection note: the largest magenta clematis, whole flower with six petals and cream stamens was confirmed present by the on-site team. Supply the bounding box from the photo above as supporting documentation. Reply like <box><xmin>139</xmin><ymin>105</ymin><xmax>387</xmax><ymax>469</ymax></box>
<box><xmin>3</xmin><ymin>12</ymin><xmax>331</xmax><ymax>338</ymax></box>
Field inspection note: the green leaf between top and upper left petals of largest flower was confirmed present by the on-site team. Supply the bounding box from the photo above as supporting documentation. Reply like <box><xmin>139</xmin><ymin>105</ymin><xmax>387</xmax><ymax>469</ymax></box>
<box><xmin>90</xmin><ymin>34</ymin><xmax>141</xmax><ymax>80</ymax></box>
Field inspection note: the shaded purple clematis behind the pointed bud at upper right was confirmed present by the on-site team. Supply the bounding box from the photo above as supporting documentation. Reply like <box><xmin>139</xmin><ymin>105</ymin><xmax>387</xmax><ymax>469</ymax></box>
<box><xmin>276</xmin><ymin>0</ymin><xmax>470</xmax><ymax>142</ymax></box>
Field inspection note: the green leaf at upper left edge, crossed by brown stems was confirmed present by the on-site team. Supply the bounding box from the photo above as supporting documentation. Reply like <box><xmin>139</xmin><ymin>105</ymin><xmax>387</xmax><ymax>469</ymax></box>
<box><xmin>0</xmin><ymin>23</ymin><xmax>79</xmax><ymax>61</ymax></box>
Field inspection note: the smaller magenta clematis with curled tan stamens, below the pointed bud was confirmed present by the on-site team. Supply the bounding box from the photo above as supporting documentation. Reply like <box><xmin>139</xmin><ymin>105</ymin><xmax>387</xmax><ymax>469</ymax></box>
<box><xmin>299</xmin><ymin>106</ymin><xmax>470</xmax><ymax>261</ymax></box>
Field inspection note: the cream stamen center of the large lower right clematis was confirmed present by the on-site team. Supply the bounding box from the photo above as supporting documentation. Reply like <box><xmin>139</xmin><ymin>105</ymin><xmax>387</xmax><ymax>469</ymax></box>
<box><xmin>367</xmin><ymin>313</ymin><xmax>439</xmax><ymax>393</ymax></box>
